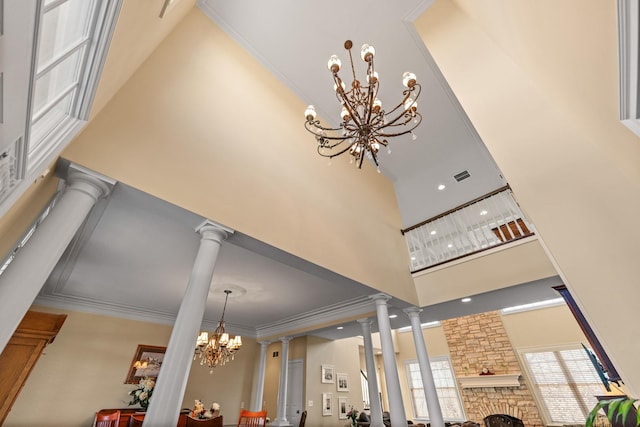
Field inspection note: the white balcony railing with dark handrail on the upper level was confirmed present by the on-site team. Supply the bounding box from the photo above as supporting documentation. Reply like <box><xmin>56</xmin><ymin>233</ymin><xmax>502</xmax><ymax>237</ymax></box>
<box><xmin>402</xmin><ymin>186</ymin><xmax>534</xmax><ymax>273</ymax></box>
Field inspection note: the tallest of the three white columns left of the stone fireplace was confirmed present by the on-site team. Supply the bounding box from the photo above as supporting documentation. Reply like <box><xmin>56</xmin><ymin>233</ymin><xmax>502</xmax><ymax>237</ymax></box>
<box><xmin>371</xmin><ymin>294</ymin><xmax>407</xmax><ymax>427</ymax></box>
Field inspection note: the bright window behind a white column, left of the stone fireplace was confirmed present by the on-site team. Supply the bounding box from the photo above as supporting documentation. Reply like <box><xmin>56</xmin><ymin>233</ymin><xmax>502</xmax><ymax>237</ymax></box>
<box><xmin>405</xmin><ymin>357</ymin><xmax>464</xmax><ymax>421</ymax></box>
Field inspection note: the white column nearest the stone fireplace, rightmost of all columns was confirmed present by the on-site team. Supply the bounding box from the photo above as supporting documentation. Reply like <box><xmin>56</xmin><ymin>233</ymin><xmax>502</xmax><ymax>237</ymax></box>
<box><xmin>404</xmin><ymin>307</ymin><xmax>444</xmax><ymax>427</ymax></box>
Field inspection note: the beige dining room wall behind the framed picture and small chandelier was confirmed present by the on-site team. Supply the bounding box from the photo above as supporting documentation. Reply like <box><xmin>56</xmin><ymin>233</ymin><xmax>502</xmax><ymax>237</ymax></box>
<box><xmin>4</xmin><ymin>306</ymin><xmax>257</xmax><ymax>427</ymax></box>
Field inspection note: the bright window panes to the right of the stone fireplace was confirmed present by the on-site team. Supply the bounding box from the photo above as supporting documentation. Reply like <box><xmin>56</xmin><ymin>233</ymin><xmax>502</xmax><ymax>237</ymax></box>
<box><xmin>522</xmin><ymin>348</ymin><xmax>602</xmax><ymax>424</ymax></box>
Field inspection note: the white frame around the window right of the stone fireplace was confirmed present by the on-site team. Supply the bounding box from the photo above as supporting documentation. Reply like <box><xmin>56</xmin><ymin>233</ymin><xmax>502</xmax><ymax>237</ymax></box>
<box><xmin>518</xmin><ymin>343</ymin><xmax>605</xmax><ymax>425</ymax></box>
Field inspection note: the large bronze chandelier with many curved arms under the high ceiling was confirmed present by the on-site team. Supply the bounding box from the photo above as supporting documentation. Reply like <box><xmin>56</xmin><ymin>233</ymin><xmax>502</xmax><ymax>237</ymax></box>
<box><xmin>304</xmin><ymin>40</ymin><xmax>422</xmax><ymax>172</ymax></box>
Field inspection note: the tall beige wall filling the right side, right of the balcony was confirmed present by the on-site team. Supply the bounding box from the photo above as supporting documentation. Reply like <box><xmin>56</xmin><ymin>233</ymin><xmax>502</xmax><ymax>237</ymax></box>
<box><xmin>416</xmin><ymin>0</ymin><xmax>640</xmax><ymax>393</ymax></box>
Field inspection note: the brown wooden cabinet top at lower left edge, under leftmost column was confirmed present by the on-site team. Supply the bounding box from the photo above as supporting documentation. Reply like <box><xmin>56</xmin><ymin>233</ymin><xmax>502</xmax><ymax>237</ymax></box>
<box><xmin>0</xmin><ymin>311</ymin><xmax>67</xmax><ymax>425</ymax></box>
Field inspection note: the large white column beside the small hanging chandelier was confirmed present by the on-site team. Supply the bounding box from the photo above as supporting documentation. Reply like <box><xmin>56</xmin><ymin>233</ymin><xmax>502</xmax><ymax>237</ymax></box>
<box><xmin>143</xmin><ymin>221</ymin><xmax>232</xmax><ymax>427</ymax></box>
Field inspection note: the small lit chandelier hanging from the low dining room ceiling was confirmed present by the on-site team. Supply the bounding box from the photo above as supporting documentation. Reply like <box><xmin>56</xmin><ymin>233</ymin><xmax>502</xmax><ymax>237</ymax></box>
<box><xmin>193</xmin><ymin>289</ymin><xmax>242</xmax><ymax>373</ymax></box>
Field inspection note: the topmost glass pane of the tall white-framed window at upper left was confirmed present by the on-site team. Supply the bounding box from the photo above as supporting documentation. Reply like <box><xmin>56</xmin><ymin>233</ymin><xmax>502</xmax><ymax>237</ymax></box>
<box><xmin>38</xmin><ymin>0</ymin><xmax>94</xmax><ymax>66</ymax></box>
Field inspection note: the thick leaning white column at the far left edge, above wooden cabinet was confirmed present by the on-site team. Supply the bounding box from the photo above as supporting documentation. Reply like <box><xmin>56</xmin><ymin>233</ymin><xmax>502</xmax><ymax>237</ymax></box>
<box><xmin>0</xmin><ymin>170</ymin><xmax>111</xmax><ymax>352</ymax></box>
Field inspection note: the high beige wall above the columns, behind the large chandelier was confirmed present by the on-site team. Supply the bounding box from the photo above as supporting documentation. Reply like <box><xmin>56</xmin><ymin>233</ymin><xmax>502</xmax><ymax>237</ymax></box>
<box><xmin>63</xmin><ymin>8</ymin><xmax>417</xmax><ymax>303</ymax></box>
